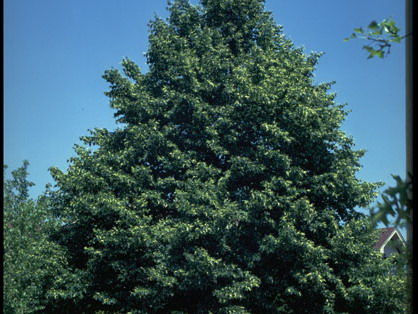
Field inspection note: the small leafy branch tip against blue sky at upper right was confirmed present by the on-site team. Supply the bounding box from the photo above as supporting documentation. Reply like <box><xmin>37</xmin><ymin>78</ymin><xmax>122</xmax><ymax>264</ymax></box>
<box><xmin>344</xmin><ymin>18</ymin><xmax>407</xmax><ymax>59</ymax></box>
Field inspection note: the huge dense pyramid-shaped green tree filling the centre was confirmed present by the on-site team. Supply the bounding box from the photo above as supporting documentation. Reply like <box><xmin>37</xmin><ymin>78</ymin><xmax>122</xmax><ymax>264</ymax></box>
<box><xmin>50</xmin><ymin>0</ymin><xmax>403</xmax><ymax>313</ymax></box>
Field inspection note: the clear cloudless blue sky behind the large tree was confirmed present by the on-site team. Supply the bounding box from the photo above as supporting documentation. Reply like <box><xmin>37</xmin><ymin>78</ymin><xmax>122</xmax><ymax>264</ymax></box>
<box><xmin>4</xmin><ymin>0</ymin><xmax>405</xmax><ymax>221</ymax></box>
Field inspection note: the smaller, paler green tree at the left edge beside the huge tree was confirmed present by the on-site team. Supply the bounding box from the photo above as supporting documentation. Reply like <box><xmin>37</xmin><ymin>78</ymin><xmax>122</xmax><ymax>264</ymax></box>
<box><xmin>3</xmin><ymin>161</ymin><xmax>85</xmax><ymax>313</ymax></box>
